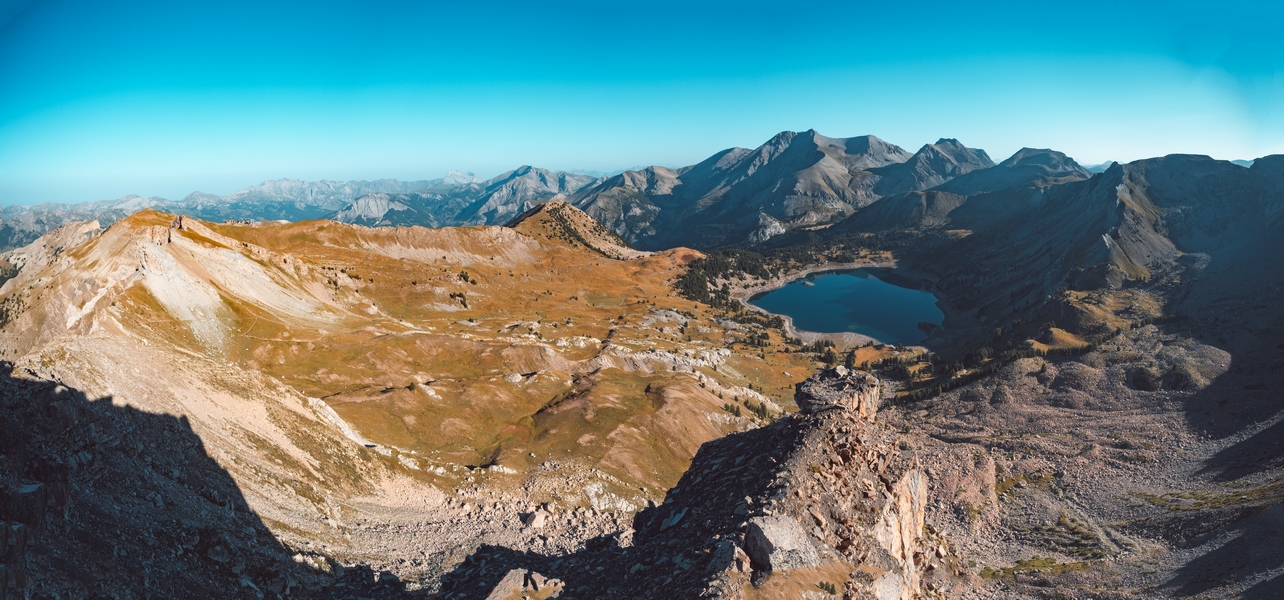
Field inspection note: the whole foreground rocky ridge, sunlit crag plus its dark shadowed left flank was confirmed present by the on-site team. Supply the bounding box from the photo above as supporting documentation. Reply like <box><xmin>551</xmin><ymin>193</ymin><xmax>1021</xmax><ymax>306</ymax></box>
<box><xmin>442</xmin><ymin>367</ymin><xmax>962</xmax><ymax>600</ymax></box>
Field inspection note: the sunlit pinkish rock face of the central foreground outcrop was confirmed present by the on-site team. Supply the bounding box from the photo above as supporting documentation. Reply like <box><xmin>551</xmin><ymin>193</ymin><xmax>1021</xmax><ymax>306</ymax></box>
<box><xmin>703</xmin><ymin>367</ymin><xmax>948</xmax><ymax>600</ymax></box>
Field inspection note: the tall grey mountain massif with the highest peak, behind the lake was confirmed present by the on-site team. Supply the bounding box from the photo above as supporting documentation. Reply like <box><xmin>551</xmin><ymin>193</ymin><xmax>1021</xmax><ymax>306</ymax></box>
<box><xmin>571</xmin><ymin>130</ymin><xmax>912</xmax><ymax>248</ymax></box>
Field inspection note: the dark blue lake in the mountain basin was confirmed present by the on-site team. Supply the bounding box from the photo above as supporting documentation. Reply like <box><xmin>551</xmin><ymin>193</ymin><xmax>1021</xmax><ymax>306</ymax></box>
<box><xmin>749</xmin><ymin>269</ymin><xmax>945</xmax><ymax>344</ymax></box>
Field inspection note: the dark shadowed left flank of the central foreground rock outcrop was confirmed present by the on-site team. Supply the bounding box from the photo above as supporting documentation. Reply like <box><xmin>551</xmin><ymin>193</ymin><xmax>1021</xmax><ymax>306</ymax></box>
<box><xmin>439</xmin><ymin>418</ymin><xmax>806</xmax><ymax>600</ymax></box>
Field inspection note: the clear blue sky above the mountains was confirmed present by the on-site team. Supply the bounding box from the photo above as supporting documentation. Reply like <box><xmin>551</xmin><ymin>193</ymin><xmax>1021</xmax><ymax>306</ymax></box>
<box><xmin>0</xmin><ymin>0</ymin><xmax>1284</xmax><ymax>206</ymax></box>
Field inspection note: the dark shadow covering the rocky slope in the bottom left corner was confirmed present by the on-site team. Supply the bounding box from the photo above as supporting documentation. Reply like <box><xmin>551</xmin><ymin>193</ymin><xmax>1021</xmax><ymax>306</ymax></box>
<box><xmin>0</xmin><ymin>362</ymin><xmax>405</xmax><ymax>597</ymax></box>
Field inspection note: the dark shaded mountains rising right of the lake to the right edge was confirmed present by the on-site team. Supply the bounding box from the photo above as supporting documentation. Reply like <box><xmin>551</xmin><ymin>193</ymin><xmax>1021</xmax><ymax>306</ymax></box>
<box><xmin>828</xmin><ymin>149</ymin><xmax>1284</xmax><ymax>319</ymax></box>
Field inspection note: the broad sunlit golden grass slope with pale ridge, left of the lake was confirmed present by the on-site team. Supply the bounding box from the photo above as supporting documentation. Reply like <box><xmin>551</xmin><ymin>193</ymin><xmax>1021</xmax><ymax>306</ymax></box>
<box><xmin>0</xmin><ymin>203</ymin><xmax>811</xmax><ymax>515</ymax></box>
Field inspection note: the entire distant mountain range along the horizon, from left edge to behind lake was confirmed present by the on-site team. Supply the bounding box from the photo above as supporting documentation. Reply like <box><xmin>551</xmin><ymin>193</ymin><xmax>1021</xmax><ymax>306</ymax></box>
<box><xmin>0</xmin><ymin>130</ymin><xmax>1278</xmax><ymax>249</ymax></box>
